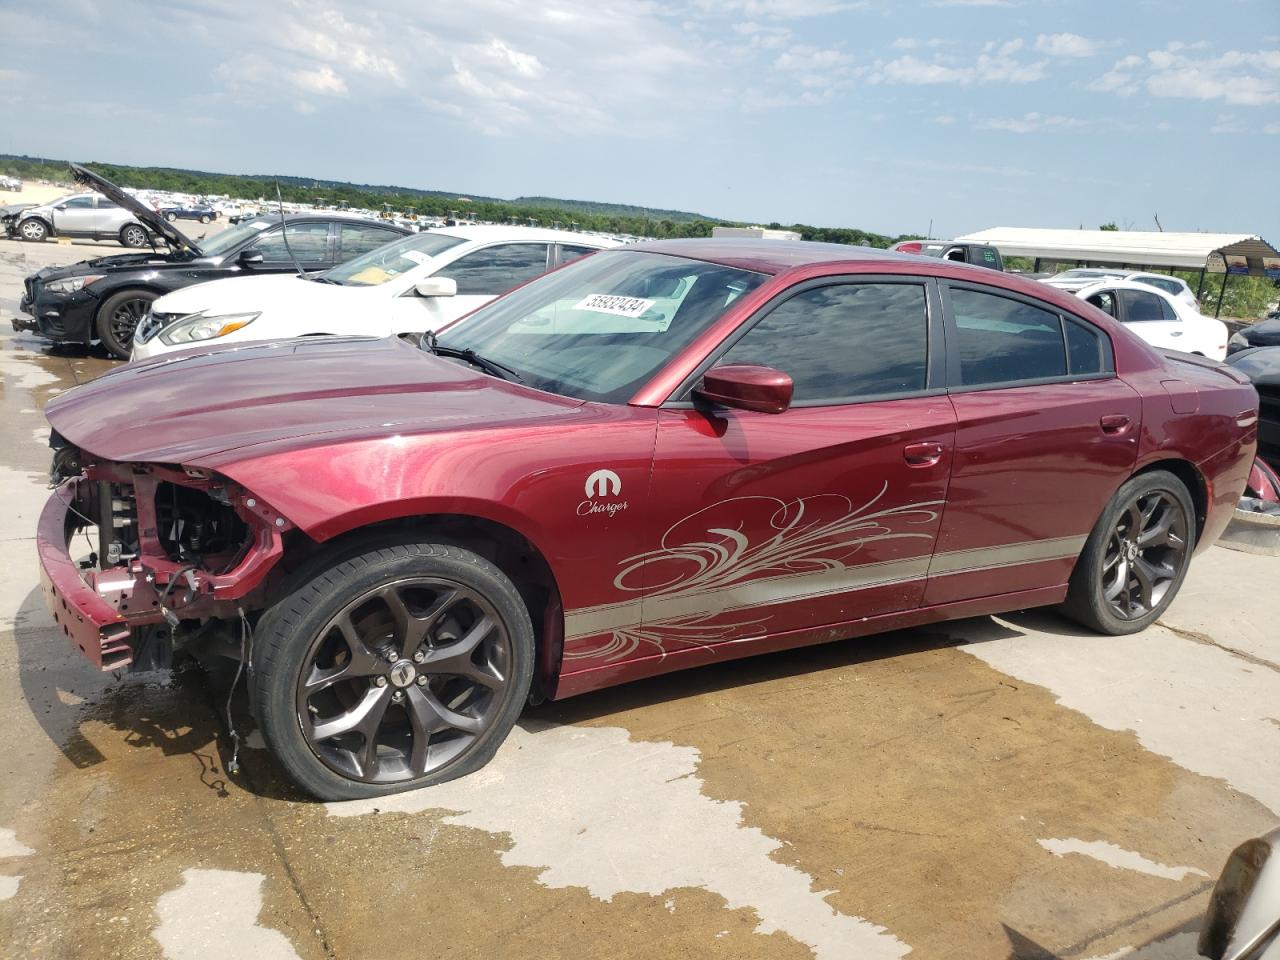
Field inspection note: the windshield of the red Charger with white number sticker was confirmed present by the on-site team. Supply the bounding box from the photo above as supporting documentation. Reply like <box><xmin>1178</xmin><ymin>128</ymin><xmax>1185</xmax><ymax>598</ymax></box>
<box><xmin>439</xmin><ymin>250</ymin><xmax>768</xmax><ymax>403</ymax></box>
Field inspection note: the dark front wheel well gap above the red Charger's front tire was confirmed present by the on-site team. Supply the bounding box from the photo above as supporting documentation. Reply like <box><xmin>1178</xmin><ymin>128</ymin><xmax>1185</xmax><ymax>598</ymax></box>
<box><xmin>285</xmin><ymin>513</ymin><xmax>564</xmax><ymax>703</ymax></box>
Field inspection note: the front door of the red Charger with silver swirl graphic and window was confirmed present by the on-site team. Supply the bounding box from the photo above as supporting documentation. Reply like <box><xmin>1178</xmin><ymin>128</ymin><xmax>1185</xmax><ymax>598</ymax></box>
<box><xmin>634</xmin><ymin>278</ymin><xmax>955</xmax><ymax>655</ymax></box>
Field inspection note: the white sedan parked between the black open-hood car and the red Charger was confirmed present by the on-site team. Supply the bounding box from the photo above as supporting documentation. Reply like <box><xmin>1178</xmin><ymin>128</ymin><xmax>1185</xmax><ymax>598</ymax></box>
<box><xmin>131</xmin><ymin>227</ymin><xmax>620</xmax><ymax>360</ymax></box>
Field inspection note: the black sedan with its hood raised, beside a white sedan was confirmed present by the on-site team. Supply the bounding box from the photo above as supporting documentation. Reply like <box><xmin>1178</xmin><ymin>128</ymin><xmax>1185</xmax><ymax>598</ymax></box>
<box><xmin>13</xmin><ymin>164</ymin><xmax>408</xmax><ymax>360</ymax></box>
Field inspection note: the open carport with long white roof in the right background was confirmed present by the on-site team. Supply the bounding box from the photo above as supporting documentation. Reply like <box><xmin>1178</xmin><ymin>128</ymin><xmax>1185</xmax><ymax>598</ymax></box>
<box><xmin>956</xmin><ymin>227</ymin><xmax>1280</xmax><ymax>312</ymax></box>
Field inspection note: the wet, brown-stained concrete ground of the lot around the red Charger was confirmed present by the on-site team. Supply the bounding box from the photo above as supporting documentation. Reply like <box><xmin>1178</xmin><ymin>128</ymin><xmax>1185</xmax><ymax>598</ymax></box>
<box><xmin>0</xmin><ymin>241</ymin><xmax>1280</xmax><ymax>960</ymax></box>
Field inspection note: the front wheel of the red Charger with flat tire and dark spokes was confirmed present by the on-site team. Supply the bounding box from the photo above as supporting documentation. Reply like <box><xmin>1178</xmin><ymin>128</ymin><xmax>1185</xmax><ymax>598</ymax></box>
<box><xmin>251</xmin><ymin>539</ymin><xmax>534</xmax><ymax>800</ymax></box>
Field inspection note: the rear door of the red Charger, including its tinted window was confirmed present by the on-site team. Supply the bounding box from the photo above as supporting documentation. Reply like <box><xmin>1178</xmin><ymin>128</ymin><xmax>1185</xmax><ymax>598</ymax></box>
<box><xmin>924</xmin><ymin>282</ymin><xmax>1142</xmax><ymax>604</ymax></box>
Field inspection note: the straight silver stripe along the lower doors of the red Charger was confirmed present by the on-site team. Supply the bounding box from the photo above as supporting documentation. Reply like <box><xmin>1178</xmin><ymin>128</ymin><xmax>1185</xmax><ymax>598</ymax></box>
<box><xmin>564</xmin><ymin>536</ymin><xmax>1087</xmax><ymax>641</ymax></box>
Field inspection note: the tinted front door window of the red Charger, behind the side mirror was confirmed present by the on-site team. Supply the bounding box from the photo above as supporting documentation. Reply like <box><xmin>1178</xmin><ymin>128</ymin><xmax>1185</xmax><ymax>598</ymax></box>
<box><xmin>719</xmin><ymin>283</ymin><xmax>929</xmax><ymax>404</ymax></box>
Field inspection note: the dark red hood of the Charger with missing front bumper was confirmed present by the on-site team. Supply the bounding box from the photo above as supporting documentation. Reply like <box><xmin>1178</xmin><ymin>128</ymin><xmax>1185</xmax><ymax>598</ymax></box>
<box><xmin>45</xmin><ymin>337</ymin><xmax>582</xmax><ymax>466</ymax></box>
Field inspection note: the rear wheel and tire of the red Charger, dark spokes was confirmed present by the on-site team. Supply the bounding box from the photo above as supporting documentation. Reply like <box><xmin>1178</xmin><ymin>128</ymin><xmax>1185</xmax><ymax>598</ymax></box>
<box><xmin>1062</xmin><ymin>470</ymin><xmax>1196</xmax><ymax>636</ymax></box>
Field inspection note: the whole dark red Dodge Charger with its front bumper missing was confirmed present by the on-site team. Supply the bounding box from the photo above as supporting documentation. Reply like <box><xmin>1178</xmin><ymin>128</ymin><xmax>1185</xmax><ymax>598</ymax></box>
<box><xmin>38</xmin><ymin>239</ymin><xmax>1258</xmax><ymax>799</ymax></box>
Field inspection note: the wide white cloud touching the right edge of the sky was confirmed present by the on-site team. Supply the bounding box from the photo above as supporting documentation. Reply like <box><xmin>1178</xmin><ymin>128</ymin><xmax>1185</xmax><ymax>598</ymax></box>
<box><xmin>1089</xmin><ymin>42</ymin><xmax>1280</xmax><ymax>106</ymax></box>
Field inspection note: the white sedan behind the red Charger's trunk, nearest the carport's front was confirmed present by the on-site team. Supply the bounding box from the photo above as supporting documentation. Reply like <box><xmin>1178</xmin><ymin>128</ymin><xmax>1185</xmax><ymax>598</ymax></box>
<box><xmin>1075</xmin><ymin>280</ymin><xmax>1228</xmax><ymax>360</ymax></box>
